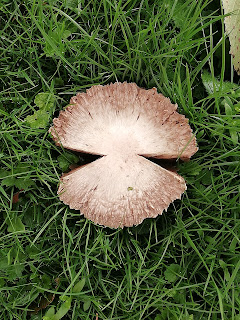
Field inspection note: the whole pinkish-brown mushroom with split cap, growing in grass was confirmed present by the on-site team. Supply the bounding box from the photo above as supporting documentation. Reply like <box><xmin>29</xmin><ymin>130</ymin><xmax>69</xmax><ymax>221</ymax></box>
<box><xmin>49</xmin><ymin>82</ymin><xmax>198</xmax><ymax>228</ymax></box>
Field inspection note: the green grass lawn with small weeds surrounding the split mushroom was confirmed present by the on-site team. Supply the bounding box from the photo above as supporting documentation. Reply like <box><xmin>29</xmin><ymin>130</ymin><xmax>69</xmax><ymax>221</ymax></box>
<box><xmin>0</xmin><ymin>0</ymin><xmax>240</xmax><ymax>320</ymax></box>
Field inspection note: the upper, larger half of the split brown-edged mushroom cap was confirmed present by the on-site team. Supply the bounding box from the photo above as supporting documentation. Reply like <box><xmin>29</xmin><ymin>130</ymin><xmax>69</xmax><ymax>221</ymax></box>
<box><xmin>50</xmin><ymin>83</ymin><xmax>197</xmax><ymax>160</ymax></box>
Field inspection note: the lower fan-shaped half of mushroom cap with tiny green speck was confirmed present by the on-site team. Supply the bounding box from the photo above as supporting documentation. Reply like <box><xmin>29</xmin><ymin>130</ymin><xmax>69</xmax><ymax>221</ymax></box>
<box><xmin>58</xmin><ymin>155</ymin><xmax>186</xmax><ymax>228</ymax></box>
